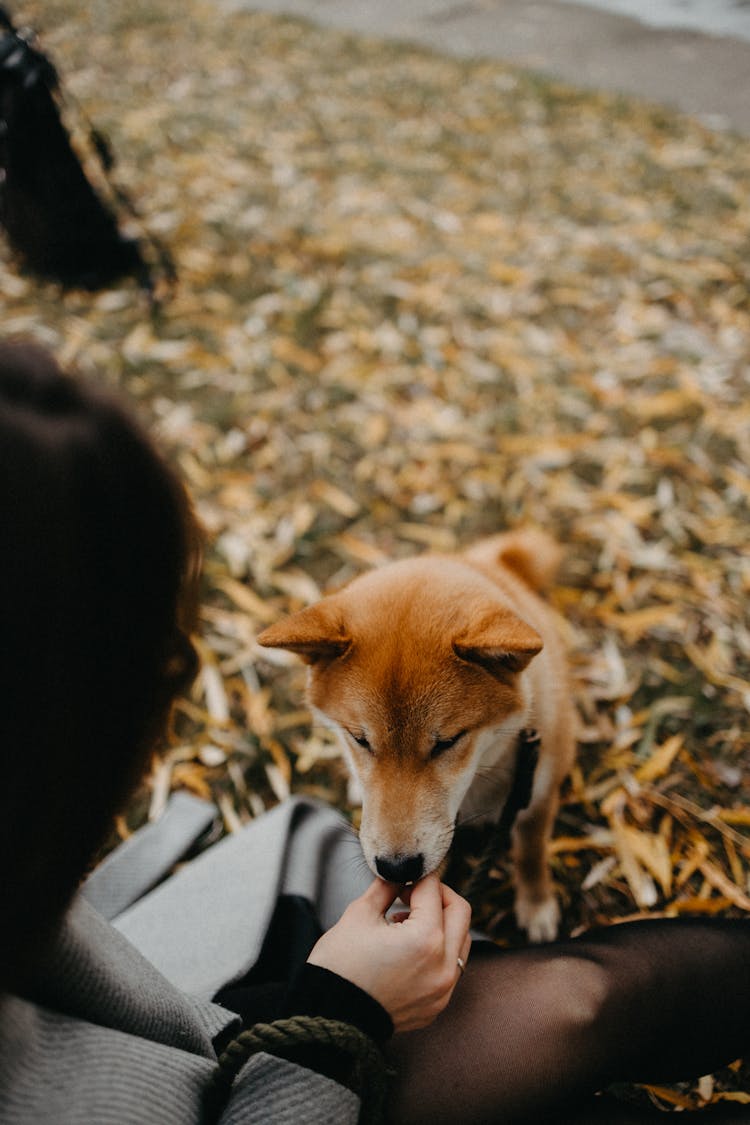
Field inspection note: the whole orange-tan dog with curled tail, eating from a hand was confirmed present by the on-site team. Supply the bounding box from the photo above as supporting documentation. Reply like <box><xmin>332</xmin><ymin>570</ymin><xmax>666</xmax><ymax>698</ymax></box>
<box><xmin>257</xmin><ymin>530</ymin><xmax>575</xmax><ymax>942</ymax></box>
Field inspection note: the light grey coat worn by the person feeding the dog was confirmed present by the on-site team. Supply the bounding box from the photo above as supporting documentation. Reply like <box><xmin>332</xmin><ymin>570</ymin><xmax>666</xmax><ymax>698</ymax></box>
<box><xmin>0</xmin><ymin>798</ymin><xmax>371</xmax><ymax>1125</ymax></box>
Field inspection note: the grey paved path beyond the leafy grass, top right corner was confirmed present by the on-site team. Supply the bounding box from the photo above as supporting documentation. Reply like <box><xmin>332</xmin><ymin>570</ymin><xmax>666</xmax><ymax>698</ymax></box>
<box><xmin>222</xmin><ymin>0</ymin><xmax>750</xmax><ymax>135</ymax></box>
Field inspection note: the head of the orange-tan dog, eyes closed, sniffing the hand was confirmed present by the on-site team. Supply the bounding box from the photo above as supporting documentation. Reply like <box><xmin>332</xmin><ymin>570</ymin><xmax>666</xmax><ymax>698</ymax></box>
<box><xmin>257</xmin><ymin>556</ymin><xmax>542</xmax><ymax>883</ymax></box>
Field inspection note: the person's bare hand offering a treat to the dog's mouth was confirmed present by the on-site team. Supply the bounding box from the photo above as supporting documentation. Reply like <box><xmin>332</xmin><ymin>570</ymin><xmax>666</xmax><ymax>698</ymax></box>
<box><xmin>308</xmin><ymin>874</ymin><xmax>471</xmax><ymax>1032</ymax></box>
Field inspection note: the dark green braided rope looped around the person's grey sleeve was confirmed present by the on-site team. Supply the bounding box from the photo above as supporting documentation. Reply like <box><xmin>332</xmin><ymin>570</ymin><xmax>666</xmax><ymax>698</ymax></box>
<box><xmin>206</xmin><ymin>1016</ymin><xmax>391</xmax><ymax>1125</ymax></box>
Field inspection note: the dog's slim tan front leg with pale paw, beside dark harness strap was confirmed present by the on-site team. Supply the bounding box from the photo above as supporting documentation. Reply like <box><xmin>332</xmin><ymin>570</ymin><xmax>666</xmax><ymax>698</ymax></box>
<box><xmin>512</xmin><ymin>745</ymin><xmax>560</xmax><ymax>942</ymax></box>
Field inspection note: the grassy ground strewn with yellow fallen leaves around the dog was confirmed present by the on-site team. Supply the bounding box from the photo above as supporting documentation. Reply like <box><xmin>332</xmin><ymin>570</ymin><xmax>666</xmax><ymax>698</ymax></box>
<box><xmin>5</xmin><ymin>0</ymin><xmax>750</xmax><ymax>1105</ymax></box>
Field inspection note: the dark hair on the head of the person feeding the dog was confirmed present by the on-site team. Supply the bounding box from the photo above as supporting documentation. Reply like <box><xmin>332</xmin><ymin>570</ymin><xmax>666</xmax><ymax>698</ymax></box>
<box><xmin>0</xmin><ymin>342</ymin><xmax>200</xmax><ymax>986</ymax></box>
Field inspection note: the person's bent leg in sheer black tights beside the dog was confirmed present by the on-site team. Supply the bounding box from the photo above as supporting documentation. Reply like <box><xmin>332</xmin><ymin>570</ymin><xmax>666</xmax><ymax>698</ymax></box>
<box><xmin>390</xmin><ymin>919</ymin><xmax>750</xmax><ymax>1125</ymax></box>
